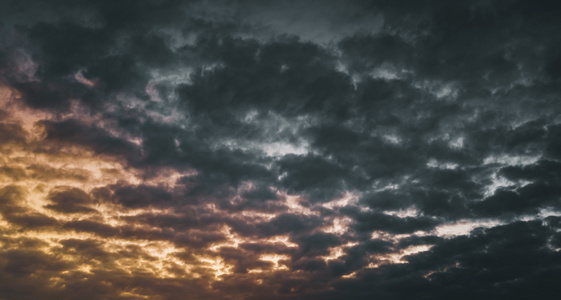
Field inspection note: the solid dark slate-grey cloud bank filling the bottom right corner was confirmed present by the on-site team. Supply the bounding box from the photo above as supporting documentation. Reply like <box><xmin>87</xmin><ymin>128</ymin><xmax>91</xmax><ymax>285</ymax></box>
<box><xmin>323</xmin><ymin>222</ymin><xmax>559</xmax><ymax>299</ymax></box>
